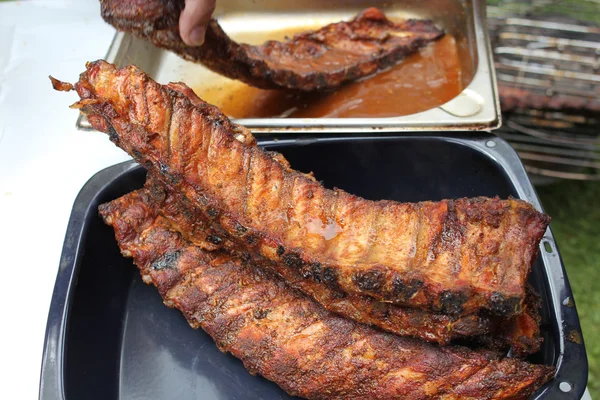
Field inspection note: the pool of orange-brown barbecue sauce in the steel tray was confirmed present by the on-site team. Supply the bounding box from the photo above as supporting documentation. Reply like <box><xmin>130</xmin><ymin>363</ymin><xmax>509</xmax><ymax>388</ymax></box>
<box><xmin>197</xmin><ymin>35</ymin><xmax>463</xmax><ymax>118</ymax></box>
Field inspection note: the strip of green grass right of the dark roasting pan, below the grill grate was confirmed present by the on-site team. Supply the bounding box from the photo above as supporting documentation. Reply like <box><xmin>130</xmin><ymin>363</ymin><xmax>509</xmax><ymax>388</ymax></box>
<box><xmin>537</xmin><ymin>181</ymin><xmax>600</xmax><ymax>399</ymax></box>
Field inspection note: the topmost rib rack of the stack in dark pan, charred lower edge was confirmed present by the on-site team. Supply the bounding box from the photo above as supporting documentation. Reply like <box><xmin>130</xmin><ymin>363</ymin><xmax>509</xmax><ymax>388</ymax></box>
<box><xmin>54</xmin><ymin>61</ymin><xmax>549</xmax><ymax>316</ymax></box>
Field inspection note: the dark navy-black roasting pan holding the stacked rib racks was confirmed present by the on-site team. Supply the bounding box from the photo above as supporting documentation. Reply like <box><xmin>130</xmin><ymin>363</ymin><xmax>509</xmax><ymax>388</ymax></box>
<box><xmin>40</xmin><ymin>132</ymin><xmax>588</xmax><ymax>400</ymax></box>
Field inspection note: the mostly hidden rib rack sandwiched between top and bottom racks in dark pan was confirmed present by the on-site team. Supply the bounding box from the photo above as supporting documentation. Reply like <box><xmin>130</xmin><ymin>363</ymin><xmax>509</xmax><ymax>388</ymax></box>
<box><xmin>138</xmin><ymin>178</ymin><xmax>541</xmax><ymax>356</ymax></box>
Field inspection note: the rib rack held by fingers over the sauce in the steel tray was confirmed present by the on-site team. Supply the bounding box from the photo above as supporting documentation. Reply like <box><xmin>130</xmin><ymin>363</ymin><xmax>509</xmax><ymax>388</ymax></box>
<box><xmin>100</xmin><ymin>0</ymin><xmax>443</xmax><ymax>91</ymax></box>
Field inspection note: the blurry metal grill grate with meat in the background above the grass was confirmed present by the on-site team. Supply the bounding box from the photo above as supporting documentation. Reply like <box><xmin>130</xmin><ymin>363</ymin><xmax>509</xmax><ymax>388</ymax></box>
<box><xmin>489</xmin><ymin>0</ymin><xmax>600</xmax><ymax>180</ymax></box>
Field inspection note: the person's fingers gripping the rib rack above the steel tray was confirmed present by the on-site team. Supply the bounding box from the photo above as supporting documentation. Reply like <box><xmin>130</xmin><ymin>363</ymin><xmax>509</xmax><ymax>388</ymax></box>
<box><xmin>179</xmin><ymin>0</ymin><xmax>216</xmax><ymax>46</ymax></box>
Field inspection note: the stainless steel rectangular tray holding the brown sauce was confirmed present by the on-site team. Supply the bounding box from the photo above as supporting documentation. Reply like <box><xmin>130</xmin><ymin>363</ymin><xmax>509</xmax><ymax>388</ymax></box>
<box><xmin>77</xmin><ymin>0</ymin><xmax>500</xmax><ymax>133</ymax></box>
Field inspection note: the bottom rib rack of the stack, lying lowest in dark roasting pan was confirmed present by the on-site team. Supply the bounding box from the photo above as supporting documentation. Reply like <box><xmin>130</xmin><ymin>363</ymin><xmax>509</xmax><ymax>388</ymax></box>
<box><xmin>100</xmin><ymin>191</ymin><xmax>553</xmax><ymax>399</ymax></box>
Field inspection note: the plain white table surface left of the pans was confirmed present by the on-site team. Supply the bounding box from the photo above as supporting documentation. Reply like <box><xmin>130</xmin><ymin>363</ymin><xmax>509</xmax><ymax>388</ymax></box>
<box><xmin>0</xmin><ymin>0</ymin><xmax>589</xmax><ymax>399</ymax></box>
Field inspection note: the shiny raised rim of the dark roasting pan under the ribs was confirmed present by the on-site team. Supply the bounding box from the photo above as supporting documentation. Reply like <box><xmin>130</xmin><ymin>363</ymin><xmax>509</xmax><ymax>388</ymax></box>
<box><xmin>39</xmin><ymin>132</ymin><xmax>588</xmax><ymax>400</ymax></box>
